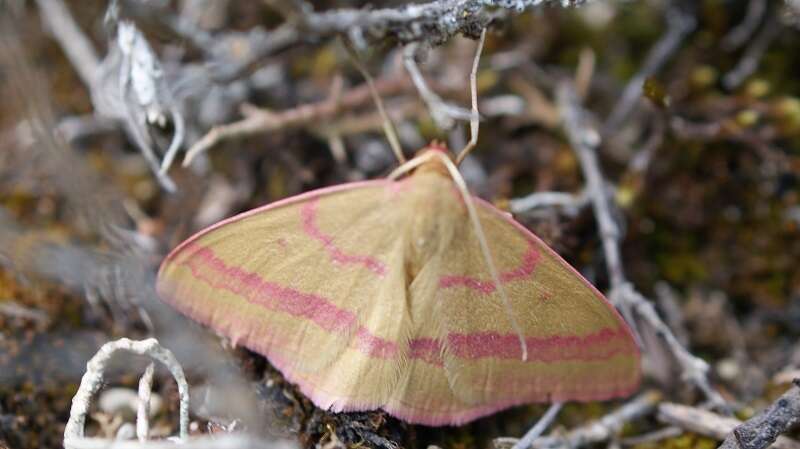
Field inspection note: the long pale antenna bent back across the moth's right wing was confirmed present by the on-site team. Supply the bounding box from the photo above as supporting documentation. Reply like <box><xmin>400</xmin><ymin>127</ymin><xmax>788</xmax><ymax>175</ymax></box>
<box><xmin>428</xmin><ymin>152</ymin><xmax>528</xmax><ymax>361</ymax></box>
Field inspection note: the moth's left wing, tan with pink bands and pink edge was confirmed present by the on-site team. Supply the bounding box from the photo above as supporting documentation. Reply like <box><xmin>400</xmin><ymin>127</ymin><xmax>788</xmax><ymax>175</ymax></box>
<box><xmin>157</xmin><ymin>181</ymin><xmax>416</xmax><ymax>411</ymax></box>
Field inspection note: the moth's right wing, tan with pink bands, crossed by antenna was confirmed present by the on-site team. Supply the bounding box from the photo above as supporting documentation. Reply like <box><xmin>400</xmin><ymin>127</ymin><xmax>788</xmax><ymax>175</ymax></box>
<box><xmin>436</xmin><ymin>198</ymin><xmax>640</xmax><ymax>414</ymax></box>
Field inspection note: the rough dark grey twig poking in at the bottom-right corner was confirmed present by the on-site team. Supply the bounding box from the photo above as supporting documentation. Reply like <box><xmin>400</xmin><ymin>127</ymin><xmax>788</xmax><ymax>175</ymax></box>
<box><xmin>720</xmin><ymin>379</ymin><xmax>800</xmax><ymax>449</ymax></box>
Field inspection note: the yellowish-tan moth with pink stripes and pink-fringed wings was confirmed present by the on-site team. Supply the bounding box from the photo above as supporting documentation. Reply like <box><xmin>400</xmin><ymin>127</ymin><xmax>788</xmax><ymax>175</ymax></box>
<box><xmin>157</xmin><ymin>30</ymin><xmax>640</xmax><ymax>425</ymax></box>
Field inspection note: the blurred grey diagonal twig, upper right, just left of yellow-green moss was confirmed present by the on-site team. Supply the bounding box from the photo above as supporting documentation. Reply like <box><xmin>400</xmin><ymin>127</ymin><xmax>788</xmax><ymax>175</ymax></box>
<box><xmin>603</xmin><ymin>6</ymin><xmax>697</xmax><ymax>131</ymax></box>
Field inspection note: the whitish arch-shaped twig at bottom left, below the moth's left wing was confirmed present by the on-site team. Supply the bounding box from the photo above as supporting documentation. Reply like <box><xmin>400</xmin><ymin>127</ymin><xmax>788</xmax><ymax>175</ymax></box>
<box><xmin>64</xmin><ymin>338</ymin><xmax>189</xmax><ymax>449</ymax></box>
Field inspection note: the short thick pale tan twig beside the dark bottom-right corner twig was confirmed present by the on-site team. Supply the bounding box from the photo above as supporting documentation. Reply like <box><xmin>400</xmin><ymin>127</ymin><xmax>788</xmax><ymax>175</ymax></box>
<box><xmin>658</xmin><ymin>403</ymin><xmax>800</xmax><ymax>449</ymax></box>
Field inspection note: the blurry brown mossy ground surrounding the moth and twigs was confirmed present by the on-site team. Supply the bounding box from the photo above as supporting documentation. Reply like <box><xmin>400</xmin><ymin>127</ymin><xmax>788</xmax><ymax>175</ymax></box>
<box><xmin>0</xmin><ymin>0</ymin><xmax>800</xmax><ymax>449</ymax></box>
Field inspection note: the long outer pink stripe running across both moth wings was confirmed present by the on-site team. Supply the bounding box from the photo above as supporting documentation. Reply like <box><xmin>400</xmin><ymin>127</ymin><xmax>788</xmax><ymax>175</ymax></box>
<box><xmin>170</xmin><ymin>243</ymin><xmax>635</xmax><ymax>365</ymax></box>
